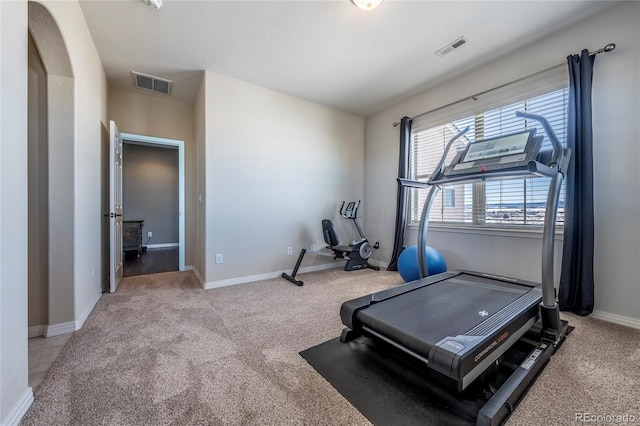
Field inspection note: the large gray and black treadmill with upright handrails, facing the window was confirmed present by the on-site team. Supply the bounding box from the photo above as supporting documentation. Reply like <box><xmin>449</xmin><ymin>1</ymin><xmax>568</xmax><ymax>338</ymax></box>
<box><xmin>340</xmin><ymin>112</ymin><xmax>571</xmax><ymax>425</ymax></box>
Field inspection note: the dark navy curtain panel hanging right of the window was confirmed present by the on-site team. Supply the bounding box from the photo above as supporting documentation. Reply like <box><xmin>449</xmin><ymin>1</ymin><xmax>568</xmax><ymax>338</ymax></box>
<box><xmin>558</xmin><ymin>49</ymin><xmax>595</xmax><ymax>315</ymax></box>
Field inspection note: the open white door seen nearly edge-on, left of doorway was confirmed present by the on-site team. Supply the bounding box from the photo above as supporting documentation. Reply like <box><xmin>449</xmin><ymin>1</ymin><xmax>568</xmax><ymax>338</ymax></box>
<box><xmin>109</xmin><ymin>121</ymin><xmax>123</xmax><ymax>293</ymax></box>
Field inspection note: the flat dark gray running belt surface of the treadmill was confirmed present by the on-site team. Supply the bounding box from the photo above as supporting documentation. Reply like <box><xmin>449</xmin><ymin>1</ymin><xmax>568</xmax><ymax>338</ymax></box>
<box><xmin>357</xmin><ymin>274</ymin><xmax>531</xmax><ymax>356</ymax></box>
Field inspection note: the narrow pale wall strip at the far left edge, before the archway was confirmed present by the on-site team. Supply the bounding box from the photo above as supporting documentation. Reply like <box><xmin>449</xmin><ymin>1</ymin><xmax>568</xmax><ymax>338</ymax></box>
<box><xmin>0</xmin><ymin>1</ymin><xmax>33</xmax><ymax>425</ymax></box>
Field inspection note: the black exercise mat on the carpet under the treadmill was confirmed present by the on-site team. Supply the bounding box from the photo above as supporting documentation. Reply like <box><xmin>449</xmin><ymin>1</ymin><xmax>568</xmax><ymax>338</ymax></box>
<box><xmin>300</xmin><ymin>337</ymin><xmax>481</xmax><ymax>426</ymax></box>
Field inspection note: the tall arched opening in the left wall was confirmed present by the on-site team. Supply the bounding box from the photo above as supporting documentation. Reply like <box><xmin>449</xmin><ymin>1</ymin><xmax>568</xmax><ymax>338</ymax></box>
<box><xmin>28</xmin><ymin>2</ymin><xmax>75</xmax><ymax>336</ymax></box>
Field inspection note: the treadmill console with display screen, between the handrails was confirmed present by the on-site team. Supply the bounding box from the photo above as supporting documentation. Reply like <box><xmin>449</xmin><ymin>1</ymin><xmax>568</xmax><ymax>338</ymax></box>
<box><xmin>443</xmin><ymin>129</ymin><xmax>543</xmax><ymax>177</ymax></box>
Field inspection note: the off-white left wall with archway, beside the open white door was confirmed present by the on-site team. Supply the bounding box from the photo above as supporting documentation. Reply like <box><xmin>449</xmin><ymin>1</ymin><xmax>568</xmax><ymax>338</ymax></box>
<box><xmin>29</xmin><ymin>1</ymin><xmax>107</xmax><ymax>336</ymax></box>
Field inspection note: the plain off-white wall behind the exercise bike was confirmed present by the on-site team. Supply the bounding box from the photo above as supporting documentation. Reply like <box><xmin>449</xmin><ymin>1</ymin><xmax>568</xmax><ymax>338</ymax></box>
<box><xmin>195</xmin><ymin>71</ymin><xmax>364</xmax><ymax>287</ymax></box>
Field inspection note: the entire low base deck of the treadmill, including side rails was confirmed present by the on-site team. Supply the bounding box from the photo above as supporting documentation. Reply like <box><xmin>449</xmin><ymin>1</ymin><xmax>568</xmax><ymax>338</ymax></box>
<box><xmin>341</xmin><ymin>271</ymin><xmax>542</xmax><ymax>390</ymax></box>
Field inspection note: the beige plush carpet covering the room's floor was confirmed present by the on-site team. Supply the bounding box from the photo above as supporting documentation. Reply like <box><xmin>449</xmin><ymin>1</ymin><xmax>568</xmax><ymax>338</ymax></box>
<box><xmin>22</xmin><ymin>270</ymin><xmax>640</xmax><ymax>425</ymax></box>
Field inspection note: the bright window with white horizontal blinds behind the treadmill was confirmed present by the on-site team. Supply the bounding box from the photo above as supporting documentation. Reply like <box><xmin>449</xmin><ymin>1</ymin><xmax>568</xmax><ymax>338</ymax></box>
<box><xmin>410</xmin><ymin>88</ymin><xmax>568</xmax><ymax>227</ymax></box>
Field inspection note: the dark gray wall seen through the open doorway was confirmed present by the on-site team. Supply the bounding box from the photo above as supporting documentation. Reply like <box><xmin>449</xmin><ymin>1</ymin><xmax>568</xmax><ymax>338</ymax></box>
<box><xmin>122</xmin><ymin>141</ymin><xmax>179</xmax><ymax>245</ymax></box>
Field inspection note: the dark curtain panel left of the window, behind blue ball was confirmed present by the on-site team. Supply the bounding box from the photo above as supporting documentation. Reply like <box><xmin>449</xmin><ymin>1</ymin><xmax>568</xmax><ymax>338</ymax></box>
<box><xmin>387</xmin><ymin>117</ymin><xmax>411</xmax><ymax>271</ymax></box>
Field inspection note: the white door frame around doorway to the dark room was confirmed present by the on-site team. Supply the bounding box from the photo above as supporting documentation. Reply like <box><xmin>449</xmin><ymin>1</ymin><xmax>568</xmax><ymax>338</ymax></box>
<box><xmin>120</xmin><ymin>133</ymin><xmax>186</xmax><ymax>271</ymax></box>
